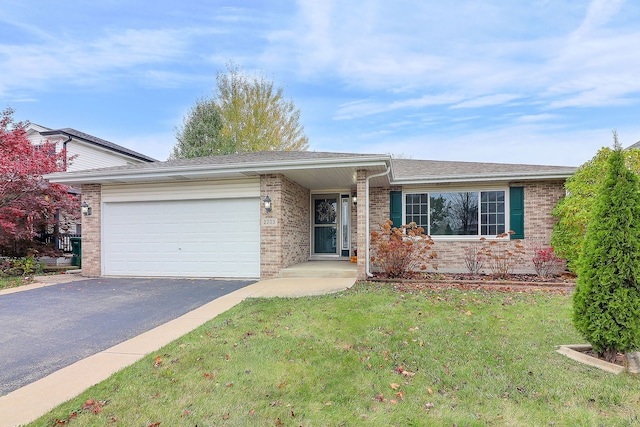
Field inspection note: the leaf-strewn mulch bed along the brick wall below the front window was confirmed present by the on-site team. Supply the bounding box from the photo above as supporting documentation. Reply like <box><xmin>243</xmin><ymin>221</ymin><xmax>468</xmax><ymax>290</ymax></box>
<box><xmin>370</xmin><ymin>273</ymin><xmax>575</xmax><ymax>294</ymax></box>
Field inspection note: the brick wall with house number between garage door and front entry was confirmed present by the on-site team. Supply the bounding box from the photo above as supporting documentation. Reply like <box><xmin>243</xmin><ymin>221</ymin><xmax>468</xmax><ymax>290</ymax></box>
<box><xmin>260</xmin><ymin>174</ymin><xmax>310</xmax><ymax>279</ymax></box>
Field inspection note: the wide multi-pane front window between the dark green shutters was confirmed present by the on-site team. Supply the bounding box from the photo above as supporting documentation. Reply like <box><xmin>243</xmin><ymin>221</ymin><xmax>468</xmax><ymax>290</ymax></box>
<box><xmin>405</xmin><ymin>190</ymin><xmax>506</xmax><ymax>236</ymax></box>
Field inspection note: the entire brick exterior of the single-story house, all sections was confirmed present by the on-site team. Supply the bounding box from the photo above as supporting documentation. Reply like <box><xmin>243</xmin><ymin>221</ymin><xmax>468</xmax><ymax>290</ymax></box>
<box><xmin>74</xmin><ymin>176</ymin><xmax>565</xmax><ymax>279</ymax></box>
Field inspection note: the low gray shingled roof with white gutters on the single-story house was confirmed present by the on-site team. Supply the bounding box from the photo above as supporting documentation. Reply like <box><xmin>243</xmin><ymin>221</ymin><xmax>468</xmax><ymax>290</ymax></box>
<box><xmin>45</xmin><ymin>151</ymin><xmax>576</xmax><ymax>188</ymax></box>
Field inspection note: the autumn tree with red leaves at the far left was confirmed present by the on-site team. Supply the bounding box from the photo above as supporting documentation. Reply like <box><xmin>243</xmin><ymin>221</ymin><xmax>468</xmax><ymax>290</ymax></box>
<box><xmin>0</xmin><ymin>108</ymin><xmax>79</xmax><ymax>255</ymax></box>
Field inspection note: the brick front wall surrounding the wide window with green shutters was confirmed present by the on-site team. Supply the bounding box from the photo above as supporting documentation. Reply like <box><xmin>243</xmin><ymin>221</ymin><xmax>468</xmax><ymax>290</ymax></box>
<box><xmin>370</xmin><ymin>180</ymin><xmax>565</xmax><ymax>272</ymax></box>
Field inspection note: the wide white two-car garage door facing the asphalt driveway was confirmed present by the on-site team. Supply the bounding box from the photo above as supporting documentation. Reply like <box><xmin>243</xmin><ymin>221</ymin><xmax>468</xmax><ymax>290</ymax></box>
<box><xmin>102</xmin><ymin>198</ymin><xmax>260</xmax><ymax>277</ymax></box>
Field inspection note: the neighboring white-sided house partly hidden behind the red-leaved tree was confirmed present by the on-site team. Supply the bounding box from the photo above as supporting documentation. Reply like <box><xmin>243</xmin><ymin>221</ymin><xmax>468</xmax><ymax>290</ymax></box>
<box><xmin>26</xmin><ymin>123</ymin><xmax>156</xmax><ymax>251</ymax></box>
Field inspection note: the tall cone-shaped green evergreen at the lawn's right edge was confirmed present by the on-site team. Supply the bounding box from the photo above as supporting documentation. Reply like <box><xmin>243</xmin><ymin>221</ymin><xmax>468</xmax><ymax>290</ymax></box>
<box><xmin>573</xmin><ymin>133</ymin><xmax>640</xmax><ymax>361</ymax></box>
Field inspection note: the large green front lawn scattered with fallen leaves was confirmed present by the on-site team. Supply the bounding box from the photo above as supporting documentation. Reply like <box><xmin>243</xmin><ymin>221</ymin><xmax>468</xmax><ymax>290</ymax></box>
<box><xmin>30</xmin><ymin>284</ymin><xmax>640</xmax><ymax>427</ymax></box>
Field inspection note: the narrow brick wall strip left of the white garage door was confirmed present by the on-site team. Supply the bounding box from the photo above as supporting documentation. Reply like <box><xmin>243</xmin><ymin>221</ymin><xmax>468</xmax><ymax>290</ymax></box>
<box><xmin>82</xmin><ymin>184</ymin><xmax>102</xmax><ymax>277</ymax></box>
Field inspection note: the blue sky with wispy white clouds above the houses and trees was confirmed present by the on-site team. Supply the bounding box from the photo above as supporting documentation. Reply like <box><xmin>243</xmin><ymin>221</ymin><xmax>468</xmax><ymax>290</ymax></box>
<box><xmin>0</xmin><ymin>0</ymin><xmax>640</xmax><ymax>166</ymax></box>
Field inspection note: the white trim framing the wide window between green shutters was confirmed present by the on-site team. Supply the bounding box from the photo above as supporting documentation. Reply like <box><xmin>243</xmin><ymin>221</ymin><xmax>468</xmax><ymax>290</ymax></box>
<box><xmin>402</xmin><ymin>186</ymin><xmax>511</xmax><ymax>242</ymax></box>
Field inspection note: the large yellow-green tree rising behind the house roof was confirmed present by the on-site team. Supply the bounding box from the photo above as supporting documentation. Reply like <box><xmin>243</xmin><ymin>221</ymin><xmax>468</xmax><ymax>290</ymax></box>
<box><xmin>171</xmin><ymin>63</ymin><xmax>309</xmax><ymax>158</ymax></box>
